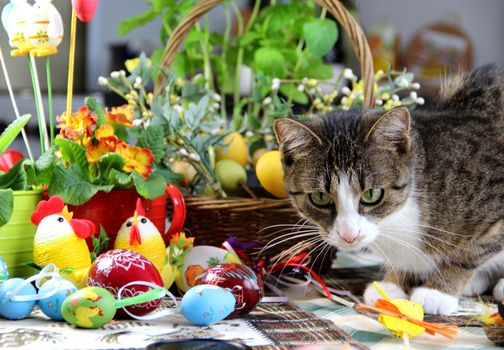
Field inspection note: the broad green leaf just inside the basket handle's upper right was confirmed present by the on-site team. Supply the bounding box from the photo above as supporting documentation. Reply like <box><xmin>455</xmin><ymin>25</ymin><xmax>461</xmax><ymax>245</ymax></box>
<box><xmin>303</xmin><ymin>19</ymin><xmax>338</xmax><ymax>57</ymax></box>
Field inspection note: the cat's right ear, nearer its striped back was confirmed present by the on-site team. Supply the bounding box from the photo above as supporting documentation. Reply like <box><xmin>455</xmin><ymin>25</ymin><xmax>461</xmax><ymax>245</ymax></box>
<box><xmin>365</xmin><ymin>106</ymin><xmax>411</xmax><ymax>153</ymax></box>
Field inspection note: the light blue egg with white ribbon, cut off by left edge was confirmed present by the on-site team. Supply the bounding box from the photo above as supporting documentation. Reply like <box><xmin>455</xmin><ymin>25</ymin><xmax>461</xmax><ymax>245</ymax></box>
<box><xmin>0</xmin><ymin>278</ymin><xmax>37</xmax><ymax>320</ymax></box>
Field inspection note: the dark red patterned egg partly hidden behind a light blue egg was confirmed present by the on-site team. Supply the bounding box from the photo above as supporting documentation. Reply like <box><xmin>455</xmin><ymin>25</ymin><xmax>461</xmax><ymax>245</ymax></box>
<box><xmin>195</xmin><ymin>263</ymin><xmax>264</xmax><ymax>318</ymax></box>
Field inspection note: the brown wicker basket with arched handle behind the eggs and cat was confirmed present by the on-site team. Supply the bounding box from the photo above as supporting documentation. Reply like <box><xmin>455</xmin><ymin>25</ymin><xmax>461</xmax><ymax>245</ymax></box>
<box><xmin>158</xmin><ymin>0</ymin><xmax>375</xmax><ymax>270</ymax></box>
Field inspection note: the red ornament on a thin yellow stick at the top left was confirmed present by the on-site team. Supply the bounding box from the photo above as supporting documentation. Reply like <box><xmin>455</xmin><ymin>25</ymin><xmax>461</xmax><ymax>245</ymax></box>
<box><xmin>66</xmin><ymin>0</ymin><xmax>98</xmax><ymax>115</ymax></box>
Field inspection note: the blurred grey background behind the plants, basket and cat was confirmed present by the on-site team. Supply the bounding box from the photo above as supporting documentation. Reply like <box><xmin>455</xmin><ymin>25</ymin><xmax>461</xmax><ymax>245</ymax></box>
<box><xmin>0</xmin><ymin>0</ymin><xmax>504</xmax><ymax>153</ymax></box>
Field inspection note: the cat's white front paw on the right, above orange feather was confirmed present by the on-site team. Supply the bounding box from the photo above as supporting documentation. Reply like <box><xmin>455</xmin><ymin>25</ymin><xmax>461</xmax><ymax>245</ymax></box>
<box><xmin>410</xmin><ymin>288</ymin><xmax>458</xmax><ymax>315</ymax></box>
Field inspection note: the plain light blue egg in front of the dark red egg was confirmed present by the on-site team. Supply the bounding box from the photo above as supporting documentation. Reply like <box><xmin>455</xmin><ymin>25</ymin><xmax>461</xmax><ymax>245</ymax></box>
<box><xmin>180</xmin><ymin>284</ymin><xmax>236</xmax><ymax>326</ymax></box>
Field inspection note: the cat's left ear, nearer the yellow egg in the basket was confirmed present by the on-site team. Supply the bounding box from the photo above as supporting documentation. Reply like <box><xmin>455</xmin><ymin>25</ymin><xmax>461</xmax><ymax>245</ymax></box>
<box><xmin>273</xmin><ymin>118</ymin><xmax>323</xmax><ymax>160</ymax></box>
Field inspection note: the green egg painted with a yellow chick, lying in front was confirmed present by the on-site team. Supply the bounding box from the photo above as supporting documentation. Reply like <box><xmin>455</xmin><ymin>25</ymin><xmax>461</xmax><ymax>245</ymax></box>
<box><xmin>61</xmin><ymin>287</ymin><xmax>116</xmax><ymax>328</ymax></box>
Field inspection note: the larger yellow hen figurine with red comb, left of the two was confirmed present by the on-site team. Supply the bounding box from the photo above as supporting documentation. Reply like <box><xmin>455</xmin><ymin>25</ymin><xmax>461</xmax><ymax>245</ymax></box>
<box><xmin>31</xmin><ymin>196</ymin><xmax>95</xmax><ymax>288</ymax></box>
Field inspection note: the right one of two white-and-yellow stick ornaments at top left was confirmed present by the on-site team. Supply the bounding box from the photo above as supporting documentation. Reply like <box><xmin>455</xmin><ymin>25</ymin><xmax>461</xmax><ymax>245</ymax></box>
<box><xmin>26</xmin><ymin>0</ymin><xmax>63</xmax><ymax>56</ymax></box>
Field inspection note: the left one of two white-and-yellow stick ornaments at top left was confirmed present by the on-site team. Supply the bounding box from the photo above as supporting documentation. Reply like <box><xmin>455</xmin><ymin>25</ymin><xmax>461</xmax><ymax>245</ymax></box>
<box><xmin>2</xmin><ymin>0</ymin><xmax>33</xmax><ymax>56</ymax></box>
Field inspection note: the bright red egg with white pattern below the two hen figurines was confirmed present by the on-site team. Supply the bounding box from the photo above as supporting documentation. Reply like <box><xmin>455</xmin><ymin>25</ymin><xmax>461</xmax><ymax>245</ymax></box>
<box><xmin>88</xmin><ymin>249</ymin><xmax>163</xmax><ymax>318</ymax></box>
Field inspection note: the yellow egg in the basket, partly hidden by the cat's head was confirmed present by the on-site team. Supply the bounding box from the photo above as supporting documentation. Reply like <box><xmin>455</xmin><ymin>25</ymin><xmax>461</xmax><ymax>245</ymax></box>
<box><xmin>256</xmin><ymin>151</ymin><xmax>288</xmax><ymax>198</ymax></box>
